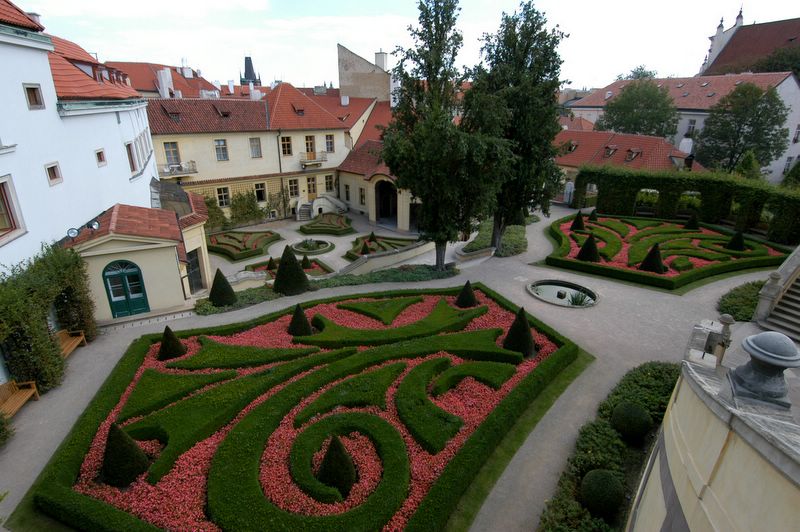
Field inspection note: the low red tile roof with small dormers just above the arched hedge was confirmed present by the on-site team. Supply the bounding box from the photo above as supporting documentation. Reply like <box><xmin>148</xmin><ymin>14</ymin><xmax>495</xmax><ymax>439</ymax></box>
<box><xmin>553</xmin><ymin>130</ymin><xmax>704</xmax><ymax>170</ymax></box>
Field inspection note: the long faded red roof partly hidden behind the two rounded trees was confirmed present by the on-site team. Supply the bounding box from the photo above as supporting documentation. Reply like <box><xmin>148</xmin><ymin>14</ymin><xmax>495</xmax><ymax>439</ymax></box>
<box><xmin>570</xmin><ymin>72</ymin><xmax>792</xmax><ymax>111</ymax></box>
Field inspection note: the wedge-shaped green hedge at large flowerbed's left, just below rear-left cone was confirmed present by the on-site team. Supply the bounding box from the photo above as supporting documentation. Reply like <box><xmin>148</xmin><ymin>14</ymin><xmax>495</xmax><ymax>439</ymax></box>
<box><xmin>117</xmin><ymin>369</ymin><xmax>236</xmax><ymax>422</ymax></box>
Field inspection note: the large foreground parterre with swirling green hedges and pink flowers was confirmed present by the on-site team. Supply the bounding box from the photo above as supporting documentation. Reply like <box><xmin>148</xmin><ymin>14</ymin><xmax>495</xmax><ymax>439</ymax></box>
<box><xmin>34</xmin><ymin>285</ymin><xmax>578</xmax><ymax>531</ymax></box>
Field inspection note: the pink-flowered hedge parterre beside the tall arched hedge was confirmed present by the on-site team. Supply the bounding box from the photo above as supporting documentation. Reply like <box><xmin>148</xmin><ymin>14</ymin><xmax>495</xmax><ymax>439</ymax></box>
<box><xmin>546</xmin><ymin>216</ymin><xmax>787</xmax><ymax>290</ymax></box>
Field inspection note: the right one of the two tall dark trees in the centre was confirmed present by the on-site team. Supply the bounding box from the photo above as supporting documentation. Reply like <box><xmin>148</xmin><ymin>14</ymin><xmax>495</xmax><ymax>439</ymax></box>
<box><xmin>462</xmin><ymin>1</ymin><xmax>564</xmax><ymax>247</ymax></box>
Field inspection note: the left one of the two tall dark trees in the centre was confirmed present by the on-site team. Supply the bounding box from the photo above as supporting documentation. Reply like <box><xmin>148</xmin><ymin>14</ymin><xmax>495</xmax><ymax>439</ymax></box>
<box><xmin>382</xmin><ymin>0</ymin><xmax>507</xmax><ymax>270</ymax></box>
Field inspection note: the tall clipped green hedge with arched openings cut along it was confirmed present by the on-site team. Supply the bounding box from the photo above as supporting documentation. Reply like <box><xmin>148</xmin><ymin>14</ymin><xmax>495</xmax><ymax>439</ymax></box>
<box><xmin>573</xmin><ymin>166</ymin><xmax>800</xmax><ymax>244</ymax></box>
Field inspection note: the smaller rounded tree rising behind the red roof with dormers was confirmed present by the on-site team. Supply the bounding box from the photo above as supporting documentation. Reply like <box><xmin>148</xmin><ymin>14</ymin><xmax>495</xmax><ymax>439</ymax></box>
<box><xmin>594</xmin><ymin>79</ymin><xmax>678</xmax><ymax>137</ymax></box>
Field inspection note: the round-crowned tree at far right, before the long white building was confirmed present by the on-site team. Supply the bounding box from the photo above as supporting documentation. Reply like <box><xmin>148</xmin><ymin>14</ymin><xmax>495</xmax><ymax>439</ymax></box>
<box><xmin>697</xmin><ymin>83</ymin><xmax>789</xmax><ymax>172</ymax></box>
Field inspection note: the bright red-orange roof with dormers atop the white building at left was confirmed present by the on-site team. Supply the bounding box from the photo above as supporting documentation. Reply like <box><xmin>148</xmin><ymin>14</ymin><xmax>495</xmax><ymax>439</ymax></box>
<box><xmin>48</xmin><ymin>35</ymin><xmax>141</xmax><ymax>100</ymax></box>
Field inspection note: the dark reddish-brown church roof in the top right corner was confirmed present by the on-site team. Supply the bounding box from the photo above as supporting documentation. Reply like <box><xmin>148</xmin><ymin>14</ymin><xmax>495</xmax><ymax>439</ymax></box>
<box><xmin>703</xmin><ymin>18</ymin><xmax>800</xmax><ymax>75</ymax></box>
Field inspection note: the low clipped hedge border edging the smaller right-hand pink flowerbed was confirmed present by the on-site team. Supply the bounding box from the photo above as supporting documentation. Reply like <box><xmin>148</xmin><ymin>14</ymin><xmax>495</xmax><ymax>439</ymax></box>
<box><xmin>545</xmin><ymin>216</ymin><xmax>789</xmax><ymax>290</ymax></box>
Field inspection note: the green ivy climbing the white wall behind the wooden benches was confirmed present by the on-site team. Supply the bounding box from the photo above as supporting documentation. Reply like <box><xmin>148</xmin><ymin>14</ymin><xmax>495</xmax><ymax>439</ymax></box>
<box><xmin>0</xmin><ymin>245</ymin><xmax>97</xmax><ymax>392</ymax></box>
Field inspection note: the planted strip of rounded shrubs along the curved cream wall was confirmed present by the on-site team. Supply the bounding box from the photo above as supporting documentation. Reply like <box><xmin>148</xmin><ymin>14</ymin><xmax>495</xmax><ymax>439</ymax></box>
<box><xmin>538</xmin><ymin>362</ymin><xmax>680</xmax><ymax>532</ymax></box>
